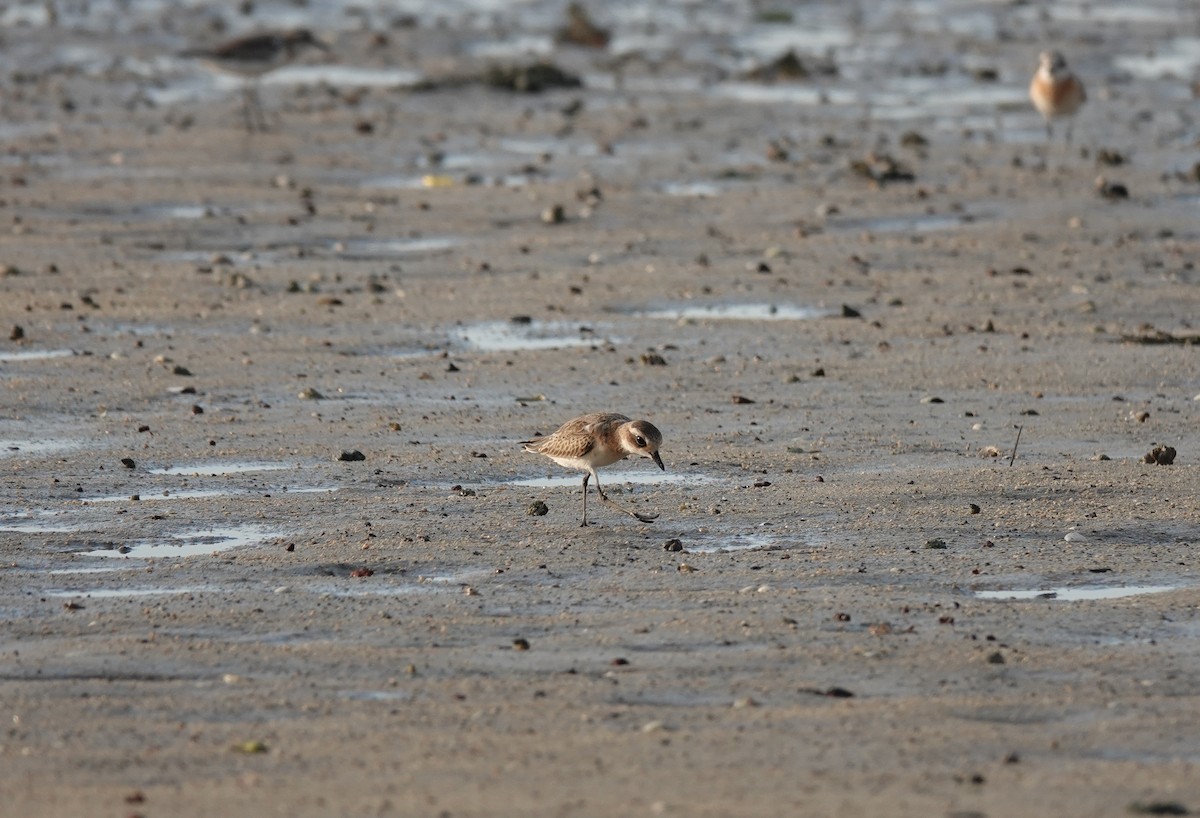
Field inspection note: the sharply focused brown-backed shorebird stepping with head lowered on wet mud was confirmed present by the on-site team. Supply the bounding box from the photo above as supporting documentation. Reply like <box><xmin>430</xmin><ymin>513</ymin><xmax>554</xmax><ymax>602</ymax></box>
<box><xmin>521</xmin><ymin>411</ymin><xmax>666</xmax><ymax>527</ymax></box>
